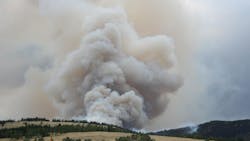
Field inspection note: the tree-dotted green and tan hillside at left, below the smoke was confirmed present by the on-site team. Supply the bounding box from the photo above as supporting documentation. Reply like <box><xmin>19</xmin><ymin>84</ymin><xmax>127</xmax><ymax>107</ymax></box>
<box><xmin>0</xmin><ymin>118</ymin><xmax>135</xmax><ymax>139</ymax></box>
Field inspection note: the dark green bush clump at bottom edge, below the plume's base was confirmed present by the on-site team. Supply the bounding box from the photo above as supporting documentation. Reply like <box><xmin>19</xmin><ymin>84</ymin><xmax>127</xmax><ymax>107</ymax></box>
<box><xmin>116</xmin><ymin>134</ymin><xmax>154</xmax><ymax>141</ymax></box>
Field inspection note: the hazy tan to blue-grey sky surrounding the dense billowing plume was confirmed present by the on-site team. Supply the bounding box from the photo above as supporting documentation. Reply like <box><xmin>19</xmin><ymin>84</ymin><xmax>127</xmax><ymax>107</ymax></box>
<box><xmin>0</xmin><ymin>0</ymin><xmax>250</xmax><ymax>129</ymax></box>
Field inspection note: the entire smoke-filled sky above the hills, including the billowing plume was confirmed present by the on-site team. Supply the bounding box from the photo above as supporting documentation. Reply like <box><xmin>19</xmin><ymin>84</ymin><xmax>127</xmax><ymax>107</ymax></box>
<box><xmin>3</xmin><ymin>0</ymin><xmax>250</xmax><ymax>129</ymax></box>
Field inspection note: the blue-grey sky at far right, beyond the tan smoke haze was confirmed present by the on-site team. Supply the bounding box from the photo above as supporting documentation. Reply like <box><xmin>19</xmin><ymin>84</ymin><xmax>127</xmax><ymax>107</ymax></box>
<box><xmin>199</xmin><ymin>0</ymin><xmax>250</xmax><ymax>119</ymax></box>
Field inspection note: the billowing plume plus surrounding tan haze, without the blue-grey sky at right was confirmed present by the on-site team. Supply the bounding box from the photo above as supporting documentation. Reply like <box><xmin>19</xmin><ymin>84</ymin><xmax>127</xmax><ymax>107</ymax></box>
<box><xmin>0</xmin><ymin>0</ymin><xmax>195</xmax><ymax>128</ymax></box>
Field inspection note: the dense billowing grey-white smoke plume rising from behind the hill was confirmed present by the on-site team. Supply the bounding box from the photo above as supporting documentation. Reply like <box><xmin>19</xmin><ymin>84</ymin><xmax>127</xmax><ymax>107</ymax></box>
<box><xmin>46</xmin><ymin>2</ymin><xmax>182</xmax><ymax>128</ymax></box>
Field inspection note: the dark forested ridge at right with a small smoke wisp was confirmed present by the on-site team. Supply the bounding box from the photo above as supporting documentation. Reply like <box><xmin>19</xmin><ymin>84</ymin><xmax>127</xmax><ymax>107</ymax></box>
<box><xmin>151</xmin><ymin>120</ymin><xmax>250</xmax><ymax>141</ymax></box>
